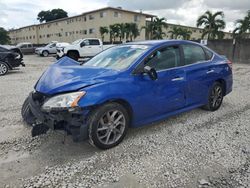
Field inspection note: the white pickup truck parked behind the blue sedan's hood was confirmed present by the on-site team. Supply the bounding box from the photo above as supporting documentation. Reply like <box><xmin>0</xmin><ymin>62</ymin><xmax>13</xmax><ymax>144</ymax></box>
<box><xmin>57</xmin><ymin>38</ymin><xmax>114</xmax><ymax>61</ymax></box>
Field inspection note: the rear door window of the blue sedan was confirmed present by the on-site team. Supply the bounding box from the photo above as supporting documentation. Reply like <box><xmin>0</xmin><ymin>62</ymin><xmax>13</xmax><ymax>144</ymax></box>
<box><xmin>182</xmin><ymin>44</ymin><xmax>206</xmax><ymax>65</ymax></box>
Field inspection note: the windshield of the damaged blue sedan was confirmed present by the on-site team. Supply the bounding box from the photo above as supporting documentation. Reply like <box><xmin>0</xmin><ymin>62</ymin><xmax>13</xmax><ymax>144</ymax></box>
<box><xmin>83</xmin><ymin>45</ymin><xmax>149</xmax><ymax>70</ymax></box>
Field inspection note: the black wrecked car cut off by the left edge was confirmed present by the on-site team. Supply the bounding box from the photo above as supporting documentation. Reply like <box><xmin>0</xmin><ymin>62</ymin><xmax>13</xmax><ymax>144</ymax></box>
<box><xmin>0</xmin><ymin>45</ymin><xmax>25</xmax><ymax>76</ymax></box>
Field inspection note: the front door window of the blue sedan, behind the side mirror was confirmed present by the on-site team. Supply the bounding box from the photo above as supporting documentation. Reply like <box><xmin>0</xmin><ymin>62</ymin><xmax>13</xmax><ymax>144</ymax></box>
<box><xmin>145</xmin><ymin>46</ymin><xmax>181</xmax><ymax>71</ymax></box>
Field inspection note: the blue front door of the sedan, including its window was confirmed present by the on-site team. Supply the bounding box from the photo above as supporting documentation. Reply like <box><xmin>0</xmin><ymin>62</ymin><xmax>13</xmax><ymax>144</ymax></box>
<box><xmin>135</xmin><ymin>46</ymin><xmax>186</xmax><ymax>123</ymax></box>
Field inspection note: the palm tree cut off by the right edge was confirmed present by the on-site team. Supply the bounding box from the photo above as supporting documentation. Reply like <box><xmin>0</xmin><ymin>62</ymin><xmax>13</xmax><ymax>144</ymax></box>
<box><xmin>233</xmin><ymin>10</ymin><xmax>250</xmax><ymax>38</ymax></box>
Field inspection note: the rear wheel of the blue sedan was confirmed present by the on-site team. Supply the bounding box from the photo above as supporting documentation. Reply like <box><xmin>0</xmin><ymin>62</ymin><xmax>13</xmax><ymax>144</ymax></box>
<box><xmin>203</xmin><ymin>82</ymin><xmax>224</xmax><ymax>111</ymax></box>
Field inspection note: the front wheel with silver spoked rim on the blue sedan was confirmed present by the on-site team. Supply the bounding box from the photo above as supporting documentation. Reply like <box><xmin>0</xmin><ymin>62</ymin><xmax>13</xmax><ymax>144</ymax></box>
<box><xmin>88</xmin><ymin>102</ymin><xmax>130</xmax><ymax>149</ymax></box>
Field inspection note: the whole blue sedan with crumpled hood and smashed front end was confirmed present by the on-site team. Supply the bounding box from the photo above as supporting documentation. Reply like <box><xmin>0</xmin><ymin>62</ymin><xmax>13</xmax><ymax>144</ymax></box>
<box><xmin>22</xmin><ymin>40</ymin><xmax>233</xmax><ymax>149</ymax></box>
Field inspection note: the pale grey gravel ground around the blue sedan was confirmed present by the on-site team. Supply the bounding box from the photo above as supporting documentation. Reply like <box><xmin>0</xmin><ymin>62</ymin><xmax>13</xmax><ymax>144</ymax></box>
<box><xmin>0</xmin><ymin>56</ymin><xmax>250</xmax><ymax>188</ymax></box>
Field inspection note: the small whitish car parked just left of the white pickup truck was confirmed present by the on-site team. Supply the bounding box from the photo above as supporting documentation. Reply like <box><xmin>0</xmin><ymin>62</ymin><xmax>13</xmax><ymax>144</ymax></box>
<box><xmin>35</xmin><ymin>41</ymin><xmax>69</xmax><ymax>57</ymax></box>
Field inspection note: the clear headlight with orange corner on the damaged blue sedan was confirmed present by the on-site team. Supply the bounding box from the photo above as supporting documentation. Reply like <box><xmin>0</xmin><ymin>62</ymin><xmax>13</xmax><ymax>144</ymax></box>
<box><xmin>42</xmin><ymin>91</ymin><xmax>86</xmax><ymax>112</ymax></box>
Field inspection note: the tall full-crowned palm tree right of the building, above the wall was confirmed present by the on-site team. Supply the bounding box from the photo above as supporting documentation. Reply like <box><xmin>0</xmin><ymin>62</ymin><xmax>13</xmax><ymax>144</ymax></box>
<box><xmin>196</xmin><ymin>10</ymin><xmax>226</xmax><ymax>39</ymax></box>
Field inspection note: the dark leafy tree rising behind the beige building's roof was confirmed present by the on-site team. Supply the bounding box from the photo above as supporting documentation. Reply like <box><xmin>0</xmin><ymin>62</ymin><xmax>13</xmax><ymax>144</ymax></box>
<box><xmin>37</xmin><ymin>8</ymin><xmax>68</xmax><ymax>23</ymax></box>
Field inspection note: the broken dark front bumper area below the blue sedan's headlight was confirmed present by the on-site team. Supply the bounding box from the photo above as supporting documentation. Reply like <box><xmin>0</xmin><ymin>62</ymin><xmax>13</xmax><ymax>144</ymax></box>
<box><xmin>28</xmin><ymin>92</ymin><xmax>88</xmax><ymax>141</ymax></box>
